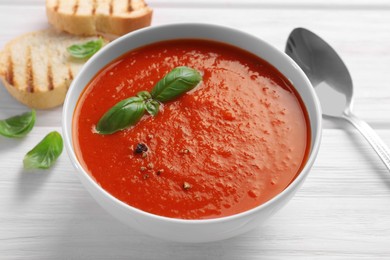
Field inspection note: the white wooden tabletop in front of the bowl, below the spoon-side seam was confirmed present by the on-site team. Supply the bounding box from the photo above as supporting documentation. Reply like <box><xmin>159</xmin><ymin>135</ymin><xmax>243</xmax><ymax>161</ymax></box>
<box><xmin>0</xmin><ymin>127</ymin><xmax>390</xmax><ymax>260</ymax></box>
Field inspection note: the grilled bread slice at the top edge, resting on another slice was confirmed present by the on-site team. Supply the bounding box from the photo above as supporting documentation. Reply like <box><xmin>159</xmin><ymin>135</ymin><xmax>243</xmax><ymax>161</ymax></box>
<box><xmin>46</xmin><ymin>0</ymin><xmax>153</xmax><ymax>36</ymax></box>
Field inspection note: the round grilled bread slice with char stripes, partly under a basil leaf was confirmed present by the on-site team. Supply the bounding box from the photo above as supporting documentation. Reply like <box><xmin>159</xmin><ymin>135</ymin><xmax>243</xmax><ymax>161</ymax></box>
<box><xmin>0</xmin><ymin>29</ymin><xmax>106</xmax><ymax>109</ymax></box>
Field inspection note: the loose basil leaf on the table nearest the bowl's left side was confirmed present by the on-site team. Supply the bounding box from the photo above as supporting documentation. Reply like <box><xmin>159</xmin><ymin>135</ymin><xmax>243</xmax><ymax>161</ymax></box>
<box><xmin>23</xmin><ymin>131</ymin><xmax>63</xmax><ymax>169</ymax></box>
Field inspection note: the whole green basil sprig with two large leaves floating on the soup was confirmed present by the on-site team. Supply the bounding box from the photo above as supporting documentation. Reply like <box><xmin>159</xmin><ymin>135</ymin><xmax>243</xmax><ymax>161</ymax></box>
<box><xmin>96</xmin><ymin>66</ymin><xmax>202</xmax><ymax>134</ymax></box>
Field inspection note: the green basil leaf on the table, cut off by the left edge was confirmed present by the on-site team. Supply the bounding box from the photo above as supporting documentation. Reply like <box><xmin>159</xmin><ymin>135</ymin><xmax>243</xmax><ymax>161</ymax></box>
<box><xmin>0</xmin><ymin>110</ymin><xmax>36</xmax><ymax>138</ymax></box>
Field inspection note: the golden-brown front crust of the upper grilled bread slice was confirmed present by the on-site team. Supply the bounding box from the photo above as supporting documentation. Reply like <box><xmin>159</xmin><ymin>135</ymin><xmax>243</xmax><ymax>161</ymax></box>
<box><xmin>46</xmin><ymin>1</ymin><xmax>153</xmax><ymax>36</ymax></box>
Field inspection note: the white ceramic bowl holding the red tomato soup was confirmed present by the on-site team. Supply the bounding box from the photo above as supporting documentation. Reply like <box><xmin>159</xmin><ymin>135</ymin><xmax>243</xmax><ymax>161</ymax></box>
<box><xmin>62</xmin><ymin>24</ymin><xmax>321</xmax><ymax>242</ymax></box>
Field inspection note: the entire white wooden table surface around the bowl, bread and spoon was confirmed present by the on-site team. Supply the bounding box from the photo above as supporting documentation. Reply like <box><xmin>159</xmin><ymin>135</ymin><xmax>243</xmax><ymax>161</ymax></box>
<box><xmin>0</xmin><ymin>0</ymin><xmax>390</xmax><ymax>260</ymax></box>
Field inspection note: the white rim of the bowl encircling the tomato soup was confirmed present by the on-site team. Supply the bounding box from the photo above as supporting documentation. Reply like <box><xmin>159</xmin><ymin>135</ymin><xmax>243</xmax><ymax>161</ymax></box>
<box><xmin>61</xmin><ymin>23</ymin><xmax>322</xmax><ymax>224</ymax></box>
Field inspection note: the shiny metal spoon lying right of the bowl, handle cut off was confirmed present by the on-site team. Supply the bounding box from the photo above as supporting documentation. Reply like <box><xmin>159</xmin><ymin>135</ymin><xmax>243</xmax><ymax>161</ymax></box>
<box><xmin>286</xmin><ymin>28</ymin><xmax>390</xmax><ymax>170</ymax></box>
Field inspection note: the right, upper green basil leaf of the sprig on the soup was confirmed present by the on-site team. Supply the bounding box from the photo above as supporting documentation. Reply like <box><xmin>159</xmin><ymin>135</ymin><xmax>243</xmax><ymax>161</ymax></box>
<box><xmin>151</xmin><ymin>66</ymin><xmax>202</xmax><ymax>102</ymax></box>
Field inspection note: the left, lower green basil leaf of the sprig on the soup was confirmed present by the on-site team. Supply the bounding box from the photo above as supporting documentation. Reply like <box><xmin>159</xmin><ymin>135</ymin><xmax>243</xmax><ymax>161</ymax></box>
<box><xmin>96</xmin><ymin>97</ymin><xmax>145</xmax><ymax>134</ymax></box>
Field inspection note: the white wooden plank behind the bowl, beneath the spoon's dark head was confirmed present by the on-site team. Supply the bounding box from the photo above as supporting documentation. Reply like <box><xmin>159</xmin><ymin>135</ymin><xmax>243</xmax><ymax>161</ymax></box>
<box><xmin>0</xmin><ymin>6</ymin><xmax>390</xmax><ymax>128</ymax></box>
